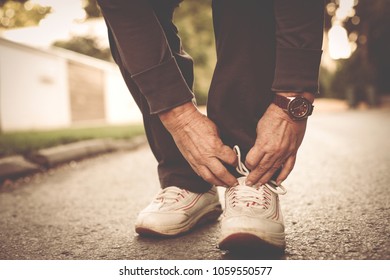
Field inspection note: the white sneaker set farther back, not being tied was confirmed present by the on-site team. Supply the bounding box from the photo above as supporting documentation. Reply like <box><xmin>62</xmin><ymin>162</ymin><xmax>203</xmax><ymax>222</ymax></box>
<box><xmin>135</xmin><ymin>187</ymin><xmax>222</xmax><ymax>236</ymax></box>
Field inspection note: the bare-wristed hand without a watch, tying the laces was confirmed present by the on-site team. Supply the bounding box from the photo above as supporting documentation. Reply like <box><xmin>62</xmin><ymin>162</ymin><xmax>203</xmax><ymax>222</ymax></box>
<box><xmin>159</xmin><ymin>103</ymin><xmax>237</xmax><ymax>186</ymax></box>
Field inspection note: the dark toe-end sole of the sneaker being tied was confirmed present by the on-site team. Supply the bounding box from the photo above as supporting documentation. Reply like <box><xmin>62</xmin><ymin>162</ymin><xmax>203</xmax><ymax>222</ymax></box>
<box><xmin>218</xmin><ymin>232</ymin><xmax>286</xmax><ymax>252</ymax></box>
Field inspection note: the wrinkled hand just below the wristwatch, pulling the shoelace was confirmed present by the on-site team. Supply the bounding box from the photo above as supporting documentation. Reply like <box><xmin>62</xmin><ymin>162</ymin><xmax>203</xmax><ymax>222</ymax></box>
<box><xmin>245</xmin><ymin>100</ymin><xmax>307</xmax><ymax>185</ymax></box>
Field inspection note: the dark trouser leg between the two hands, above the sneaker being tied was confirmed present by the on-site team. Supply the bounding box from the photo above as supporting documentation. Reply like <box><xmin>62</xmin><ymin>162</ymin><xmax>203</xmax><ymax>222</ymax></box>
<box><xmin>208</xmin><ymin>0</ymin><xmax>276</xmax><ymax>166</ymax></box>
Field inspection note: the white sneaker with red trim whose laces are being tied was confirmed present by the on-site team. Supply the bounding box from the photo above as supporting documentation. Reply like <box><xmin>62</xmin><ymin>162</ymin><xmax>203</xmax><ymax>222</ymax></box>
<box><xmin>219</xmin><ymin>147</ymin><xmax>286</xmax><ymax>251</ymax></box>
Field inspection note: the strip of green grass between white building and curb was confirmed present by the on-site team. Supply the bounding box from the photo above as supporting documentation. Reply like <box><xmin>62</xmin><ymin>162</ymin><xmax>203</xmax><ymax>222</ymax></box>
<box><xmin>0</xmin><ymin>125</ymin><xmax>145</xmax><ymax>157</ymax></box>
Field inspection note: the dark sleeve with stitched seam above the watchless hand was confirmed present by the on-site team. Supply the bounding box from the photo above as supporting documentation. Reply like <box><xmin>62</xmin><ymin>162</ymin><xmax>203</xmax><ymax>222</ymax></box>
<box><xmin>98</xmin><ymin>0</ymin><xmax>194</xmax><ymax>114</ymax></box>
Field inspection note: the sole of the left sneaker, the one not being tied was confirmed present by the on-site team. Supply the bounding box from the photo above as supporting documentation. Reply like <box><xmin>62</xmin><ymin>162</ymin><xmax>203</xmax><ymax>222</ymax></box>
<box><xmin>135</xmin><ymin>205</ymin><xmax>222</xmax><ymax>237</ymax></box>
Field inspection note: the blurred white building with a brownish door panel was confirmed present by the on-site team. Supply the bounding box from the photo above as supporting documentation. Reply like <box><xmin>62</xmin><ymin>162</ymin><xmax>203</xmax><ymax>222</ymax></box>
<box><xmin>0</xmin><ymin>38</ymin><xmax>142</xmax><ymax>131</ymax></box>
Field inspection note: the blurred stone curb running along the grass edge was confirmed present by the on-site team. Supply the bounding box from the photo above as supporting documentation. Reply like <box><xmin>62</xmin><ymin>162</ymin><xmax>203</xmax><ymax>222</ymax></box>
<box><xmin>0</xmin><ymin>135</ymin><xmax>147</xmax><ymax>182</ymax></box>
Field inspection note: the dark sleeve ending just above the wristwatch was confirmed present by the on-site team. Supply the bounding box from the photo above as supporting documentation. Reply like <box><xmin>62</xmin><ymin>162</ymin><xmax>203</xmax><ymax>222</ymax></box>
<box><xmin>272</xmin><ymin>0</ymin><xmax>324</xmax><ymax>94</ymax></box>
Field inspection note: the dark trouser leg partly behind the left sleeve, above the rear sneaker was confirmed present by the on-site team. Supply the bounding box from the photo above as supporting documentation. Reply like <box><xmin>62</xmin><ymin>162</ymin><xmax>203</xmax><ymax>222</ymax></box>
<box><xmin>100</xmin><ymin>0</ymin><xmax>210</xmax><ymax>192</ymax></box>
